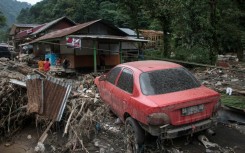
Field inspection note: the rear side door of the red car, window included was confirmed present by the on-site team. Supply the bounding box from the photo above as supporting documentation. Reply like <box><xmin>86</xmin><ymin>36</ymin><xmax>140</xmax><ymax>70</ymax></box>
<box><xmin>111</xmin><ymin>68</ymin><xmax>134</xmax><ymax>119</ymax></box>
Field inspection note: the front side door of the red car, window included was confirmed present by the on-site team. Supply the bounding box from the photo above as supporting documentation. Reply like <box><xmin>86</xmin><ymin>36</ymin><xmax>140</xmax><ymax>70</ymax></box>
<box><xmin>100</xmin><ymin>67</ymin><xmax>122</xmax><ymax>107</ymax></box>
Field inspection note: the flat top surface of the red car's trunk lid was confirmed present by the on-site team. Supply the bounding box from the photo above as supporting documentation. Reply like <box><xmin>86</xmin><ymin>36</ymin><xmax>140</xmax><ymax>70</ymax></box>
<box><xmin>147</xmin><ymin>86</ymin><xmax>219</xmax><ymax>107</ymax></box>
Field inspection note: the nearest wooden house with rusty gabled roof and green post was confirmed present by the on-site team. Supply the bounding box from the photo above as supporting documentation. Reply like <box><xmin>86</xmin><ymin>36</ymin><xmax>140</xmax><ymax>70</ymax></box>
<box><xmin>31</xmin><ymin>20</ymin><xmax>147</xmax><ymax>71</ymax></box>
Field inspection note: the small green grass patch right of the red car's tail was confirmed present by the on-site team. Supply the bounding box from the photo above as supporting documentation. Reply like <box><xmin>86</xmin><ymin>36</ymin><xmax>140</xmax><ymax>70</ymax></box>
<box><xmin>221</xmin><ymin>95</ymin><xmax>245</xmax><ymax>109</ymax></box>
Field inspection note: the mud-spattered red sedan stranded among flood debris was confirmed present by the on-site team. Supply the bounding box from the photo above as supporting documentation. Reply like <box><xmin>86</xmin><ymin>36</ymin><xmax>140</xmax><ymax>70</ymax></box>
<box><xmin>95</xmin><ymin>61</ymin><xmax>220</xmax><ymax>150</ymax></box>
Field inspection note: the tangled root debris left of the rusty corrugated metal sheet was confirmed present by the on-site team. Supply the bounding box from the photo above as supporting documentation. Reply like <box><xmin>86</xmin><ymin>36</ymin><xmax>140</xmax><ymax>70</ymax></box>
<box><xmin>0</xmin><ymin>58</ymin><xmax>32</xmax><ymax>136</ymax></box>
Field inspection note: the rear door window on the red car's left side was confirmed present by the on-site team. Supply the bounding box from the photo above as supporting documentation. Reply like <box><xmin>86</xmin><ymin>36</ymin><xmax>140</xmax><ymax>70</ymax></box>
<box><xmin>117</xmin><ymin>69</ymin><xmax>134</xmax><ymax>93</ymax></box>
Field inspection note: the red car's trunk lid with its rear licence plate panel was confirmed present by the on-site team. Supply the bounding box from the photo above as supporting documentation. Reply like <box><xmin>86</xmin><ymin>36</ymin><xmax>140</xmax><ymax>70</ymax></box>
<box><xmin>148</xmin><ymin>86</ymin><xmax>219</xmax><ymax>126</ymax></box>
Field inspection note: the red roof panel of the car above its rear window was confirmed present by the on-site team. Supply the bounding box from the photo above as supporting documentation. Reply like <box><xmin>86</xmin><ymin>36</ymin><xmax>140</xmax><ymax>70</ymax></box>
<box><xmin>120</xmin><ymin>60</ymin><xmax>182</xmax><ymax>72</ymax></box>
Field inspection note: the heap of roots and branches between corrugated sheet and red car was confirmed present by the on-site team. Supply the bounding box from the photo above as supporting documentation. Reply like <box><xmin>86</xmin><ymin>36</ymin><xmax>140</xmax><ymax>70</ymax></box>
<box><xmin>57</xmin><ymin>73</ymin><xmax>112</xmax><ymax>152</ymax></box>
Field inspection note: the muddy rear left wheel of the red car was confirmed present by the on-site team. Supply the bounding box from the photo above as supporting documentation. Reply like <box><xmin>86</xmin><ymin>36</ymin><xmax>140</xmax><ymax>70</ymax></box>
<box><xmin>125</xmin><ymin>117</ymin><xmax>145</xmax><ymax>153</ymax></box>
